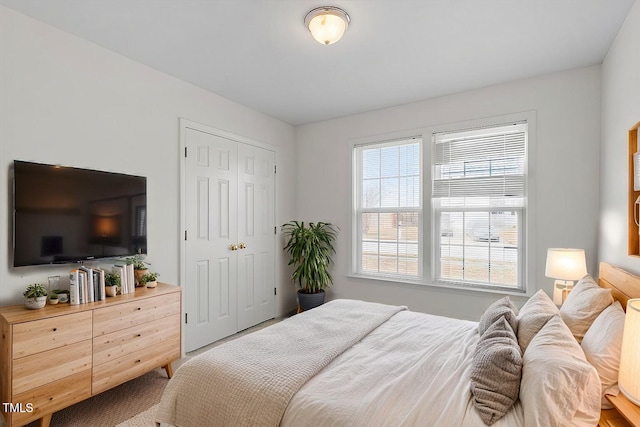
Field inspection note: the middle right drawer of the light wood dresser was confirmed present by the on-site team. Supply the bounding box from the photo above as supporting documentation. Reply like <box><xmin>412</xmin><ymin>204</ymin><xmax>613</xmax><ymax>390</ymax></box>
<box><xmin>93</xmin><ymin>313</ymin><xmax>180</xmax><ymax>366</ymax></box>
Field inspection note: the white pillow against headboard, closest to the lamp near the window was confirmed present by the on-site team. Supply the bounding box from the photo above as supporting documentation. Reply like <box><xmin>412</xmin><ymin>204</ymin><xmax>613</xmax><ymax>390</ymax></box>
<box><xmin>560</xmin><ymin>275</ymin><xmax>613</xmax><ymax>342</ymax></box>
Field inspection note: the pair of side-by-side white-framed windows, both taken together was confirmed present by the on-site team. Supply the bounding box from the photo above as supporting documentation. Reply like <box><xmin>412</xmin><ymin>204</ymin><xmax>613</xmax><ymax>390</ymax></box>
<box><xmin>353</xmin><ymin>119</ymin><xmax>534</xmax><ymax>292</ymax></box>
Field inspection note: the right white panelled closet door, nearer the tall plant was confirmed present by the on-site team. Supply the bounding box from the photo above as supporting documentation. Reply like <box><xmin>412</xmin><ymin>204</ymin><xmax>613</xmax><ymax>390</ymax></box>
<box><xmin>238</xmin><ymin>143</ymin><xmax>275</xmax><ymax>330</ymax></box>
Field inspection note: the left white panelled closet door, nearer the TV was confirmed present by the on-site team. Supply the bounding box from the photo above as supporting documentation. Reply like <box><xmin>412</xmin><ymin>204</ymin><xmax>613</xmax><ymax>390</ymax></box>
<box><xmin>183</xmin><ymin>128</ymin><xmax>238</xmax><ymax>351</ymax></box>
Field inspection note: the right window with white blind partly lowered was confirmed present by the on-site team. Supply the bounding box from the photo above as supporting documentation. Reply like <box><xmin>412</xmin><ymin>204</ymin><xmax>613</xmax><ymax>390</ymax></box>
<box><xmin>432</xmin><ymin>123</ymin><xmax>527</xmax><ymax>291</ymax></box>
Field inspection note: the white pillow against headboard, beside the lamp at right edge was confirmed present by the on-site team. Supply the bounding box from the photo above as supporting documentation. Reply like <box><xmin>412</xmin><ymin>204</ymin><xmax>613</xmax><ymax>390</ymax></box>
<box><xmin>581</xmin><ymin>301</ymin><xmax>624</xmax><ymax>409</ymax></box>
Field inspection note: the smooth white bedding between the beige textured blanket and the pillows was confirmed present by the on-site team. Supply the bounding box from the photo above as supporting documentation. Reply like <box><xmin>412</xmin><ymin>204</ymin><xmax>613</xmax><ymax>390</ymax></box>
<box><xmin>281</xmin><ymin>311</ymin><xmax>524</xmax><ymax>427</ymax></box>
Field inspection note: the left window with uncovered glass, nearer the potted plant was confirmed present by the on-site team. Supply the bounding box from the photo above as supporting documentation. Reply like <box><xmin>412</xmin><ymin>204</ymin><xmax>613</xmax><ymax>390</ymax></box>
<box><xmin>354</xmin><ymin>138</ymin><xmax>422</xmax><ymax>279</ymax></box>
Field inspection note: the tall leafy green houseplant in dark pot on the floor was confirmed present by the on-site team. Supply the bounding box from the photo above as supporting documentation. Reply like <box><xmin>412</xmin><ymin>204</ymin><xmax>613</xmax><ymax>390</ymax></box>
<box><xmin>282</xmin><ymin>221</ymin><xmax>338</xmax><ymax>311</ymax></box>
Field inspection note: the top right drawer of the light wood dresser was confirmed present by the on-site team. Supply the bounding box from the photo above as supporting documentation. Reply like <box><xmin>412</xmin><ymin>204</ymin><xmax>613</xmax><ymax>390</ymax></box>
<box><xmin>93</xmin><ymin>292</ymin><xmax>180</xmax><ymax>337</ymax></box>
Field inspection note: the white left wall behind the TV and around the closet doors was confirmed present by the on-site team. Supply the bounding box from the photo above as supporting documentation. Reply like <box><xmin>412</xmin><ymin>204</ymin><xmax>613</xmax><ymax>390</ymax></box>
<box><xmin>0</xmin><ymin>6</ymin><xmax>296</xmax><ymax>315</ymax></box>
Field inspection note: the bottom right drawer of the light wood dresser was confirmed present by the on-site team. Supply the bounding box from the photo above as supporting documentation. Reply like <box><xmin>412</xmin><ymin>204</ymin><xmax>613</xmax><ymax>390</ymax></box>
<box><xmin>92</xmin><ymin>331</ymin><xmax>180</xmax><ymax>394</ymax></box>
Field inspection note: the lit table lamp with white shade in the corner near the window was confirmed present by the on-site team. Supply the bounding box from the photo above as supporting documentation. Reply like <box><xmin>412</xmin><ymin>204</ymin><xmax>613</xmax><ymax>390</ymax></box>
<box><xmin>544</xmin><ymin>248</ymin><xmax>587</xmax><ymax>305</ymax></box>
